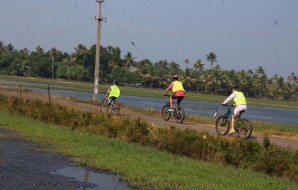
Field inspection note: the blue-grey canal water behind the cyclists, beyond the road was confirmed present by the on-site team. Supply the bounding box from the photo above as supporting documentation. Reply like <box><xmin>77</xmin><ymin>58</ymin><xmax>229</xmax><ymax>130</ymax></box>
<box><xmin>29</xmin><ymin>88</ymin><xmax>298</xmax><ymax>125</ymax></box>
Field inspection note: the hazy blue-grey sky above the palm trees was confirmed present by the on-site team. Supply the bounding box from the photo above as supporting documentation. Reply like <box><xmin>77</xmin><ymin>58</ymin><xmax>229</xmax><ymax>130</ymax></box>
<box><xmin>0</xmin><ymin>0</ymin><xmax>298</xmax><ymax>78</ymax></box>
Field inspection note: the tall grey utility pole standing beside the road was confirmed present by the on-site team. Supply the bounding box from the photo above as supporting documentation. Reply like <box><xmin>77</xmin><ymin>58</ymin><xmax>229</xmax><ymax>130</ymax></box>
<box><xmin>93</xmin><ymin>0</ymin><xmax>104</xmax><ymax>101</ymax></box>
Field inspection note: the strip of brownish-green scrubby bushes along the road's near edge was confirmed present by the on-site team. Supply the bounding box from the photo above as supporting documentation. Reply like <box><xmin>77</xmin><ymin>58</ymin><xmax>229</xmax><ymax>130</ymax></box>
<box><xmin>0</xmin><ymin>95</ymin><xmax>298</xmax><ymax>180</ymax></box>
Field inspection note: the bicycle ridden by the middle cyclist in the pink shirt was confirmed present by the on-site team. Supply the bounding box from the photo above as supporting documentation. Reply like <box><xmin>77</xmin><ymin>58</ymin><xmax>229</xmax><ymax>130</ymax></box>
<box><xmin>161</xmin><ymin>94</ymin><xmax>185</xmax><ymax>123</ymax></box>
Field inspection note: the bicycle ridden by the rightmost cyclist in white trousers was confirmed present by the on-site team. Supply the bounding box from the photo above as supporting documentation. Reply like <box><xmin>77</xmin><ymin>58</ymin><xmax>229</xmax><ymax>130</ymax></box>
<box><xmin>214</xmin><ymin>104</ymin><xmax>253</xmax><ymax>139</ymax></box>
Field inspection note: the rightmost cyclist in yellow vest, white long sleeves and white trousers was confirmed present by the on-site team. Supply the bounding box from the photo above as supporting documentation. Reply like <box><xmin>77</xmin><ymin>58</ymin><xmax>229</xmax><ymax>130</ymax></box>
<box><xmin>222</xmin><ymin>85</ymin><xmax>247</xmax><ymax>134</ymax></box>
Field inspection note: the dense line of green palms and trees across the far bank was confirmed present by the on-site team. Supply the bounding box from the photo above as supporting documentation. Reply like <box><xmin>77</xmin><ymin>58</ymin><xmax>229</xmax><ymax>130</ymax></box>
<box><xmin>0</xmin><ymin>41</ymin><xmax>298</xmax><ymax>101</ymax></box>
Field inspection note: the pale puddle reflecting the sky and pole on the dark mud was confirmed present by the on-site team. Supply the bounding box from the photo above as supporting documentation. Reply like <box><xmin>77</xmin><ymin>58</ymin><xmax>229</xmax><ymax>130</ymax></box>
<box><xmin>52</xmin><ymin>166</ymin><xmax>132</xmax><ymax>190</ymax></box>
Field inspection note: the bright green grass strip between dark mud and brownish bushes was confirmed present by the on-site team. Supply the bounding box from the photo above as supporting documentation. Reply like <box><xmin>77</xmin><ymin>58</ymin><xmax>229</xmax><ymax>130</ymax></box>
<box><xmin>0</xmin><ymin>111</ymin><xmax>297</xmax><ymax>190</ymax></box>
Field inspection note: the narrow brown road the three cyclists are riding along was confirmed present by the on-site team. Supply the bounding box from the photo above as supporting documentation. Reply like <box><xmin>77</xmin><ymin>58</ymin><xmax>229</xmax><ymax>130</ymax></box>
<box><xmin>0</xmin><ymin>89</ymin><xmax>298</xmax><ymax>150</ymax></box>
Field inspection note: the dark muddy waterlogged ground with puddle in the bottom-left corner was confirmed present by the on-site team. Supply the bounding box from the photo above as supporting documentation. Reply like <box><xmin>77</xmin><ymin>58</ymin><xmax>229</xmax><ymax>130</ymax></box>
<box><xmin>0</xmin><ymin>129</ymin><xmax>133</xmax><ymax>190</ymax></box>
